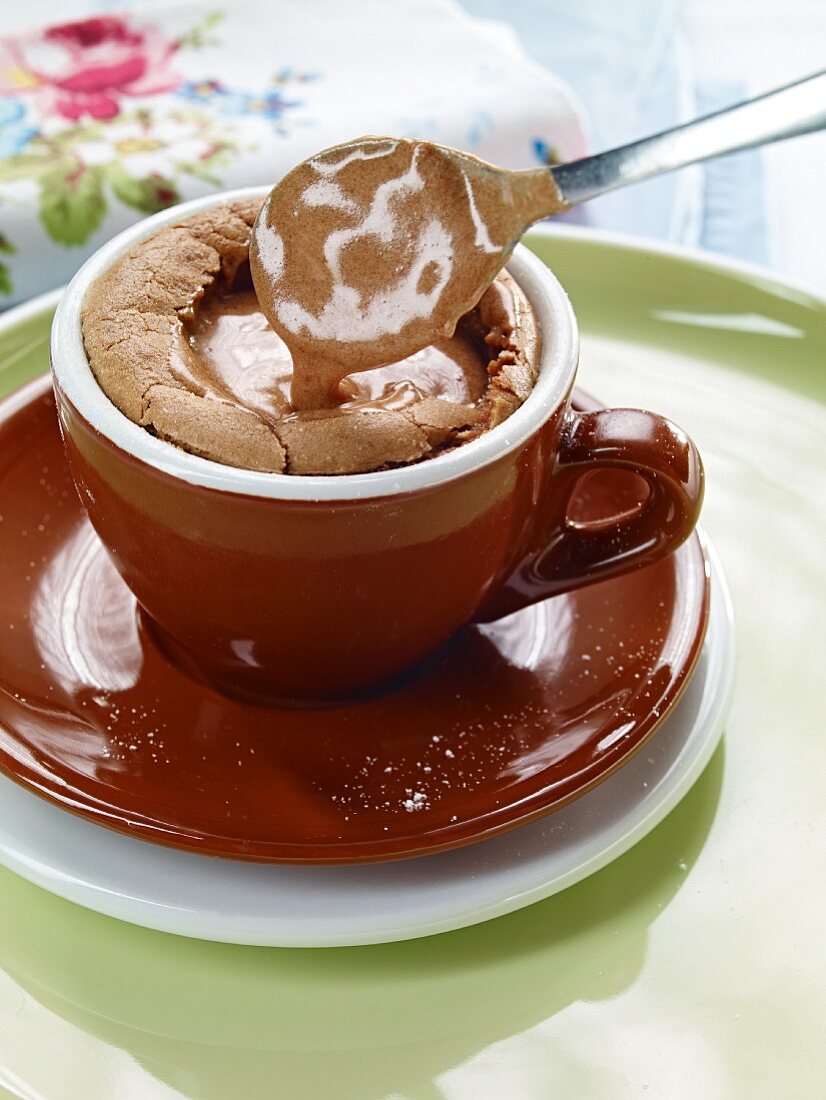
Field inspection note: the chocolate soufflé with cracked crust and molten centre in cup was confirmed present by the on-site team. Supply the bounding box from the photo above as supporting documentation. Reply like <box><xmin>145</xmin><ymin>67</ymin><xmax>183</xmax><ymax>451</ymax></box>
<box><xmin>82</xmin><ymin>199</ymin><xmax>540</xmax><ymax>474</ymax></box>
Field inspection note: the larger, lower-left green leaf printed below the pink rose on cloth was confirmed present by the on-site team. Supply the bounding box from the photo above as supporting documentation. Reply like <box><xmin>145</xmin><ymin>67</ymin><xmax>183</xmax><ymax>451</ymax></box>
<box><xmin>40</xmin><ymin>161</ymin><xmax>107</xmax><ymax>244</ymax></box>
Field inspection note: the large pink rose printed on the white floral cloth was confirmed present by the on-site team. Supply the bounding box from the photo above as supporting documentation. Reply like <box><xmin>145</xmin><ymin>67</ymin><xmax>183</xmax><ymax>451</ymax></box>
<box><xmin>0</xmin><ymin>15</ymin><xmax>181</xmax><ymax>122</ymax></box>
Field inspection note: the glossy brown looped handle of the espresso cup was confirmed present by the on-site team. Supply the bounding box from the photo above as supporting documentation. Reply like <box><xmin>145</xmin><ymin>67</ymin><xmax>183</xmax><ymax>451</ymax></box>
<box><xmin>474</xmin><ymin>409</ymin><xmax>704</xmax><ymax>623</ymax></box>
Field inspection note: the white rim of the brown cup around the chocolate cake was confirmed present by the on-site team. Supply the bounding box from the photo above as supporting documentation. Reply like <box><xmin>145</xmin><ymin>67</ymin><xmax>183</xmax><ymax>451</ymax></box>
<box><xmin>52</xmin><ymin>187</ymin><xmax>579</xmax><ymax>501</ymax></box>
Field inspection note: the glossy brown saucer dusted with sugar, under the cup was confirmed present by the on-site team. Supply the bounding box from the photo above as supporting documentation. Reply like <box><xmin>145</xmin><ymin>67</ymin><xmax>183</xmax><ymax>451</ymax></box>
<box><xmin>0</xmin><ymin>378</ymin><xmax>708</xmax><ymax>864</ymax></box>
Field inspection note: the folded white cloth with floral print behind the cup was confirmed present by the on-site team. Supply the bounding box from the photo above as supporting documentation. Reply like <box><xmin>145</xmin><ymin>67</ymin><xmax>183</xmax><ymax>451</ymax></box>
<box><xmin>0</xmin><ymin>0</ymin><xmax>584</xmax><ymax>306</ymax></box>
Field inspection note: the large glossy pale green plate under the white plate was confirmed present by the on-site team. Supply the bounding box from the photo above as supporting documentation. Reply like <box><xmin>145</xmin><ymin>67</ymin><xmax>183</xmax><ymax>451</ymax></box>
<box><xmin>0</xmin><ymin>232</ymin><xmax>826</xmax><ymax>1100</ymax></box>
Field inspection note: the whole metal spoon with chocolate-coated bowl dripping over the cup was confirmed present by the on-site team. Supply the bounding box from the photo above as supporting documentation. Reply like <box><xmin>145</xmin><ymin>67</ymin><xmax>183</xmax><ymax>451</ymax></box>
<box><xmin>250</xmin><ymin>74</ymin><xmax>826</xmax><ymax>408</ymax></box>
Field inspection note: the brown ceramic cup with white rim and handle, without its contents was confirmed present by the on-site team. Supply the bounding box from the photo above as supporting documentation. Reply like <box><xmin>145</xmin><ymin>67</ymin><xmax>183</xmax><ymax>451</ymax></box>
<box><xmin>52</xmin><ymin>190</ymin><xmax>703</xmax><ymax>703</ymax></box>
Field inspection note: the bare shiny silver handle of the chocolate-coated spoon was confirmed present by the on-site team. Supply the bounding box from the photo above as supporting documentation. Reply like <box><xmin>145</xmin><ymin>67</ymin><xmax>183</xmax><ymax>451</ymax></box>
<box><xmin>551</xmin><ymin>72</ymin><xmax>826</xmax><ymax>206</ymax></box>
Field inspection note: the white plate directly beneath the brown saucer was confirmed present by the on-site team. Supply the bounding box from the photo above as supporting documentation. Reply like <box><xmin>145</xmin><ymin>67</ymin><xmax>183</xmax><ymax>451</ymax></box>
<box><xmin>0</xmin><ymin>541</ymin><xmax>734</xmax><ymax>947</ymax></box>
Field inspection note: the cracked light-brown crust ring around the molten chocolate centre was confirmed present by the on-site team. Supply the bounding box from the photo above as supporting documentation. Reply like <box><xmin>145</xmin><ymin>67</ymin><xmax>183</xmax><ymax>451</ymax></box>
<box><xmin>81</xmin><ymin>199</ymin><xmax>539</xmax><ymax>474</ymax></box>
